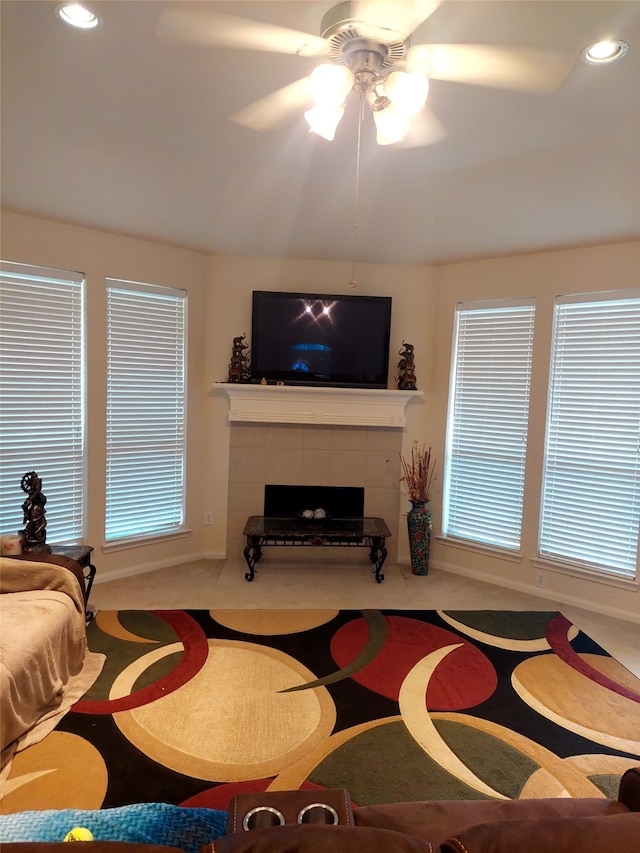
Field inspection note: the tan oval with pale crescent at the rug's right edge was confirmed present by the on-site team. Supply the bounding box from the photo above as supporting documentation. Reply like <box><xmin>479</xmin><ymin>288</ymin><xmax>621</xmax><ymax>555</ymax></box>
<box><xmin>511</xmin><ymin>655</ymin><xmax>640</xmax><ymax>755</ymax></box>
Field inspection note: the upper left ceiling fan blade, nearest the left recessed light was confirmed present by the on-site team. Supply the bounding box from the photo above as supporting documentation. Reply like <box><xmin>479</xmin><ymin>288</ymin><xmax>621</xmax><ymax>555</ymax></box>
<box><xmin>157</xmin><ymin>9</ymin><xmax>328</xmax><ymax>56</ymax></box>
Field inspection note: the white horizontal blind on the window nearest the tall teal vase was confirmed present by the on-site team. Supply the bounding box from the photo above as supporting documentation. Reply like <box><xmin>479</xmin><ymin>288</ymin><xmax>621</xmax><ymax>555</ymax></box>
<box><xmin>443</xmin><ymin>301</ymin><xmax>535</xmax><ymax>550</ymax></box>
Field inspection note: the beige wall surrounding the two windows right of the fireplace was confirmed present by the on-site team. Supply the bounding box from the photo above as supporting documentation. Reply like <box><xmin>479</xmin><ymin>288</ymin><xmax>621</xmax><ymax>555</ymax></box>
<box><xmin>431</xmin><ymin>243</ymin><xmax>640</xmax><ymax>619</ymax></box>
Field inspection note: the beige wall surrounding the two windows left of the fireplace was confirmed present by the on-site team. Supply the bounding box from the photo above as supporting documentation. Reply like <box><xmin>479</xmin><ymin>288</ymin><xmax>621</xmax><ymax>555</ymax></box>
<box><xmin>2</xmin><ymin>212</ymin><xmax>205</xmax><ymax>577</ymax></box>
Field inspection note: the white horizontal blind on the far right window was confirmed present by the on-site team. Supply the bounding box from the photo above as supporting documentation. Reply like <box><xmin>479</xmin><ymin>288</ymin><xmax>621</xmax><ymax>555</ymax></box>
<box><xmin>540</xmin><ymin>291</ymin><xmax>640</xmax><ymax>578</ymax></box>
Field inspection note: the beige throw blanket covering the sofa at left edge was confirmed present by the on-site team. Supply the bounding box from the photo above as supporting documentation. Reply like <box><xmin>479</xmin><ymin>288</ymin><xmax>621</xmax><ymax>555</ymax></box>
<box><xmin>0</xmin><ymin>558</ymin><xmax>104</xmax><ymax>765</ymax></box>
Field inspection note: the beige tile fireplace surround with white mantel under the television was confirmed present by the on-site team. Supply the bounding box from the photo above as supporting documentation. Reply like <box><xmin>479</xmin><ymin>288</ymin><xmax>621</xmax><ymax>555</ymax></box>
<box><xmin>214</xmin><ymin>383</ymin><xmax>422</xmax><ymax>564</ymax></box>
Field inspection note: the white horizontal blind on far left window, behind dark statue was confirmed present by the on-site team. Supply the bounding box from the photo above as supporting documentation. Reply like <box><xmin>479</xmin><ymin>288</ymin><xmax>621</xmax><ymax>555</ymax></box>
<box><xmin>0</xmin><ymin>261</ymin><xmax>85</xmax><ymax>543</ymax></box>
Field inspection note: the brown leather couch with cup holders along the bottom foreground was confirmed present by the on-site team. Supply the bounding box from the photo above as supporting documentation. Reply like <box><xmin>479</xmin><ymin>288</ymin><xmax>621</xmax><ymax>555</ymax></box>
<box><xmin>3</xmin><ymin>767</ymin><xmax>640</xmax><ymax>853</ymax></box>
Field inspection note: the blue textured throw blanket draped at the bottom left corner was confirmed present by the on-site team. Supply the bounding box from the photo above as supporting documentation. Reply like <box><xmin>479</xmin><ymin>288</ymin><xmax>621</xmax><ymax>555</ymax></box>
<box><xmin>0</xmin><ymin>803</ymin><xmax>227</xmax><ymax>853</ymax></box>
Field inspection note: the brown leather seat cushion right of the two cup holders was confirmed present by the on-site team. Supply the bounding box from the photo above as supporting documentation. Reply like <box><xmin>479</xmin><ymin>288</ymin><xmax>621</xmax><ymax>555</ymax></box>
<box><xmin>353</xmin><ymin>797</ymin><xmax>628</xmax><ymax>846</ymax></box>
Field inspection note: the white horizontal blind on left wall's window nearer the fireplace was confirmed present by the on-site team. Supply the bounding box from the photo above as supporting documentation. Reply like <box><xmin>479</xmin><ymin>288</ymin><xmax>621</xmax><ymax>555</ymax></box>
<box><xmin>105</xmin><ymin>280</ymin><xmax>186</xmax><ymax>541</ymax></box>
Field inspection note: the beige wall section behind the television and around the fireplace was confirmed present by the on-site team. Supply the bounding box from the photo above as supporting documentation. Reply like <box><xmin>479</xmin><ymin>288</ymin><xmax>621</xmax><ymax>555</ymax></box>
<box><xmin>205</xmin><ymin>256</ymin><xmax>438</xmax><ymax>559</ymax></box>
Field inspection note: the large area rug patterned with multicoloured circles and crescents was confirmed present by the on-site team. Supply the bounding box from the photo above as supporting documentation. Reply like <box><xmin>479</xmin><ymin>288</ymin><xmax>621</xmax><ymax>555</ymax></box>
<box><xmin>1</xmin><ymin>610</ymin><xmax>640</xmax><ymax>813</ymax></box>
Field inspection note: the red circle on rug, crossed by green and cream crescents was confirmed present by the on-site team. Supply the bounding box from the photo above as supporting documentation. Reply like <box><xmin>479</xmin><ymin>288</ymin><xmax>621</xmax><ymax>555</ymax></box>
<box><xmin>331</xmin><ymin>616</ymin><xmax>498</xmax><ymax>711</ymax></box>
